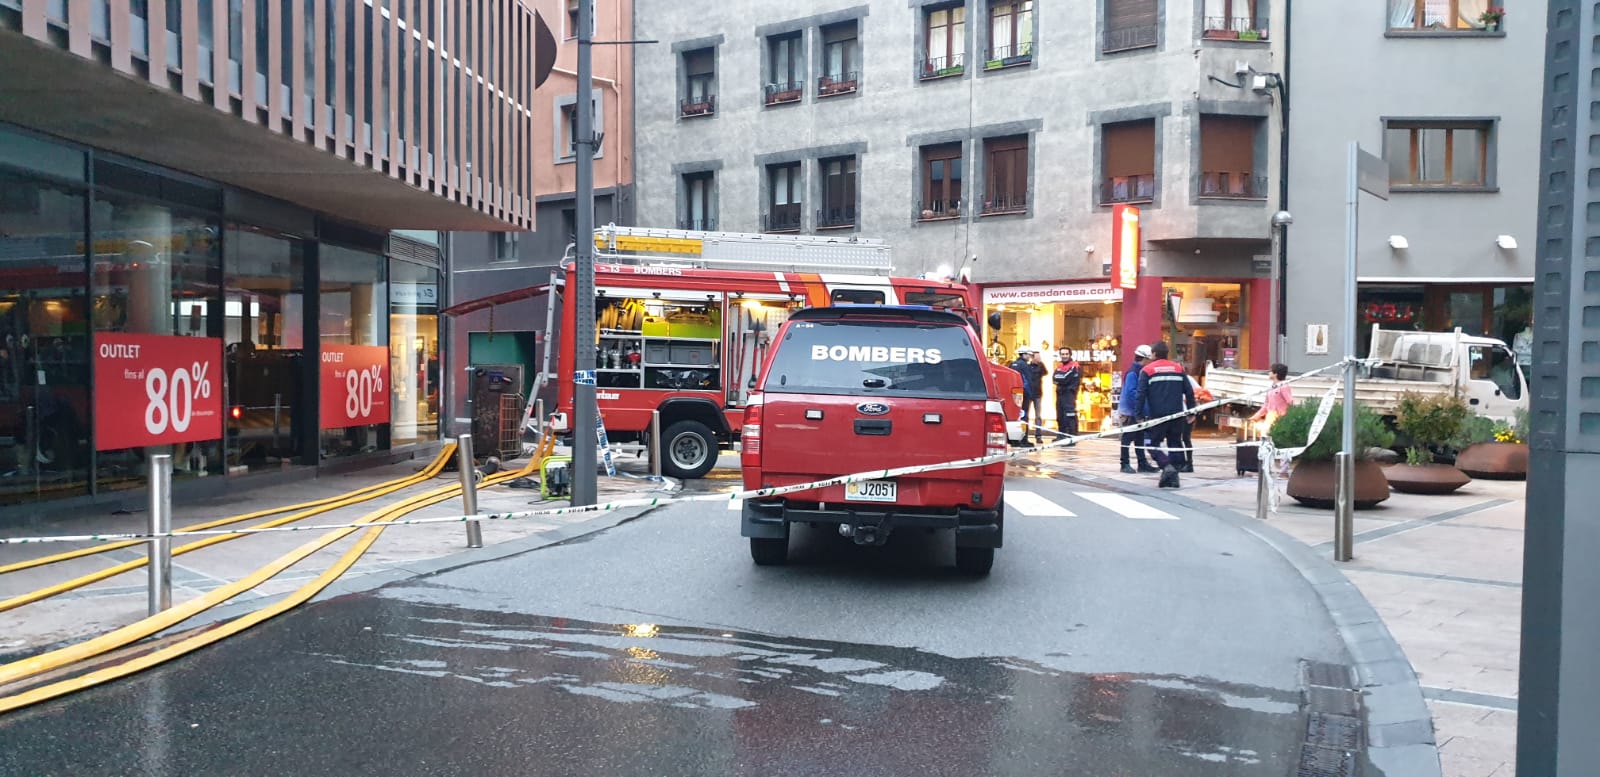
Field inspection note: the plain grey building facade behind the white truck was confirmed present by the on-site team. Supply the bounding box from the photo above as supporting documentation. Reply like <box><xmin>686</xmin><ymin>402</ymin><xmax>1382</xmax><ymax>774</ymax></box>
<box><xmin>1286</xmin><ymin>0</ymin><xmax>1547</xmax><ymax>375</ymax></box>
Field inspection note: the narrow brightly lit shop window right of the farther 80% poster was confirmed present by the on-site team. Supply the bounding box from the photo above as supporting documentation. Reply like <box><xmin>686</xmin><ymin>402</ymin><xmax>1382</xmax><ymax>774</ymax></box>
<box><xmin>389</xmin><ymin>259</ymin><xmax>442</xmax><ymax>444</ymax></box>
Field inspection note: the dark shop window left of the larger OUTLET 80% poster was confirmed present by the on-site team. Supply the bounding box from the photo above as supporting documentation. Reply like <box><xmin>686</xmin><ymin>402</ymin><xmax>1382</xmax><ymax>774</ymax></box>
<box><xmin>0</xmin><ymin>173</ymin><xmax>91</xmax><ymax>505</ymax></box>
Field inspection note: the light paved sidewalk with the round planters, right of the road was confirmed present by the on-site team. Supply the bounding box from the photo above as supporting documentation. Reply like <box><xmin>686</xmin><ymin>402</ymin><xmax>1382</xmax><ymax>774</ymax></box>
<box><xmin>1034</xmin><ymin>435</ymin><xmax>1526</xmax><ymax>777</ymax></box>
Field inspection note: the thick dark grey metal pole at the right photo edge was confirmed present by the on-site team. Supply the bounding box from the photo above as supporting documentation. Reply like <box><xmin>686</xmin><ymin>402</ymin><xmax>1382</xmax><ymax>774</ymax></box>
<box><xmin>1517</xmin><ymin>0</ymin><xmax>1600</xmax><ymax>767</ymax></box>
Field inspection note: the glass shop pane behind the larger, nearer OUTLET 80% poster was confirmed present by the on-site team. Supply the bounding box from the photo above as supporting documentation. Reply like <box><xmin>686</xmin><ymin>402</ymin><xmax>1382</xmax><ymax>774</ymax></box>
<box><xmin>91</xmin><ymin>193</ymin><xmax>224</xmax><ymax>491</ymax></box>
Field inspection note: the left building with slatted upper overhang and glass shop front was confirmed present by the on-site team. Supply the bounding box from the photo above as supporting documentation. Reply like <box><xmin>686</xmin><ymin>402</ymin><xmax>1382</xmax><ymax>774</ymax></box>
<box><xmin>0</xmin><ymin>0</ymin><xmax>539</xmax><ymax>516</ymax></box>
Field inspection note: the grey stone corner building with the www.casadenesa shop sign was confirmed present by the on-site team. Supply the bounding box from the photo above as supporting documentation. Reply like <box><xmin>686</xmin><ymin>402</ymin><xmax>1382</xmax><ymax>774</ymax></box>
<box><xmin>635</xmin><ymin>0</ymin><xmax>1280</xmax><ymax>424</ymax></box>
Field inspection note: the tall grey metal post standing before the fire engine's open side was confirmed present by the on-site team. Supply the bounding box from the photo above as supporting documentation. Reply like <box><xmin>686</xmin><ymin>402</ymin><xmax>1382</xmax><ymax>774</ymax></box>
<box><xmin>570</xmin><ymin>0</ymin><xmax>600</xmax><ymax>507</ymax></box>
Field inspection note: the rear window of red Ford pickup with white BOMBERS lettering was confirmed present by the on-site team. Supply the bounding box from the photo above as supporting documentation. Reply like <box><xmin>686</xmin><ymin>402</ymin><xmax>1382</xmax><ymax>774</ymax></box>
<box><xmin>765</xmin><ymin>321</ymin><xmax>989</xmax><ymax>400</ymax></box>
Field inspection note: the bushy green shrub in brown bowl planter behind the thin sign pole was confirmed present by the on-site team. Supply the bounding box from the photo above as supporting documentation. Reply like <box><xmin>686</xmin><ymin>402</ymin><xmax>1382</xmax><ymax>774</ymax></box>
<box><xmin>1270</xmin><ymin>401</ymin><xmax>1395</xmax><ymax>510</ymax></box>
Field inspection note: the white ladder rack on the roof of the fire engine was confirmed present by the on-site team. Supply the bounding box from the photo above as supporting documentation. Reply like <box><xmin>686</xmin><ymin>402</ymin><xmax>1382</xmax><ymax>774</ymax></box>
<box><xmin>582</xmin><ymin>224</ymin><xmax>893</xmax><ymax>275</ymax></box>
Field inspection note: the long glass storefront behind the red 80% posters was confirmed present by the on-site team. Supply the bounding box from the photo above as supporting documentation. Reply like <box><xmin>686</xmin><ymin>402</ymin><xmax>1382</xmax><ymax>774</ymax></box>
<box><xmin>0</xmin><ymin>121</ymin><xmax>443</xmax><ymax>507</ymax></box>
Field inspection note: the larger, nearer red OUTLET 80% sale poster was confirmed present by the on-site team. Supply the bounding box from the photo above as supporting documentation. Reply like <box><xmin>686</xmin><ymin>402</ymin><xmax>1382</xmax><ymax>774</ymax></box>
<box><xmin>94</xmin><ymin>333</ymin><xmax>222</xmax><ymax>451</ymax></box>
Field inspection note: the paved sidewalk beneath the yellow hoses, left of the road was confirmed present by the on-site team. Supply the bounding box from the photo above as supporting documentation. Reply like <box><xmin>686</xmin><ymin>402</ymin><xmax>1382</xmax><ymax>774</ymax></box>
<box><xmin>0</xmin><ymin>456</ymin><xmax>678</xmax><ymax>657</ymax></box>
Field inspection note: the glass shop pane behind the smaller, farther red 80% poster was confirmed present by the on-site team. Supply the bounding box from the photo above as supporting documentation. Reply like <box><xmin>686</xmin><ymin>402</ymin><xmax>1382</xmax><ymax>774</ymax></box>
<box><xmin>317</xmin><ymin>245</ymin><xmax>394</xmax><ymax>459</ymax></box>
